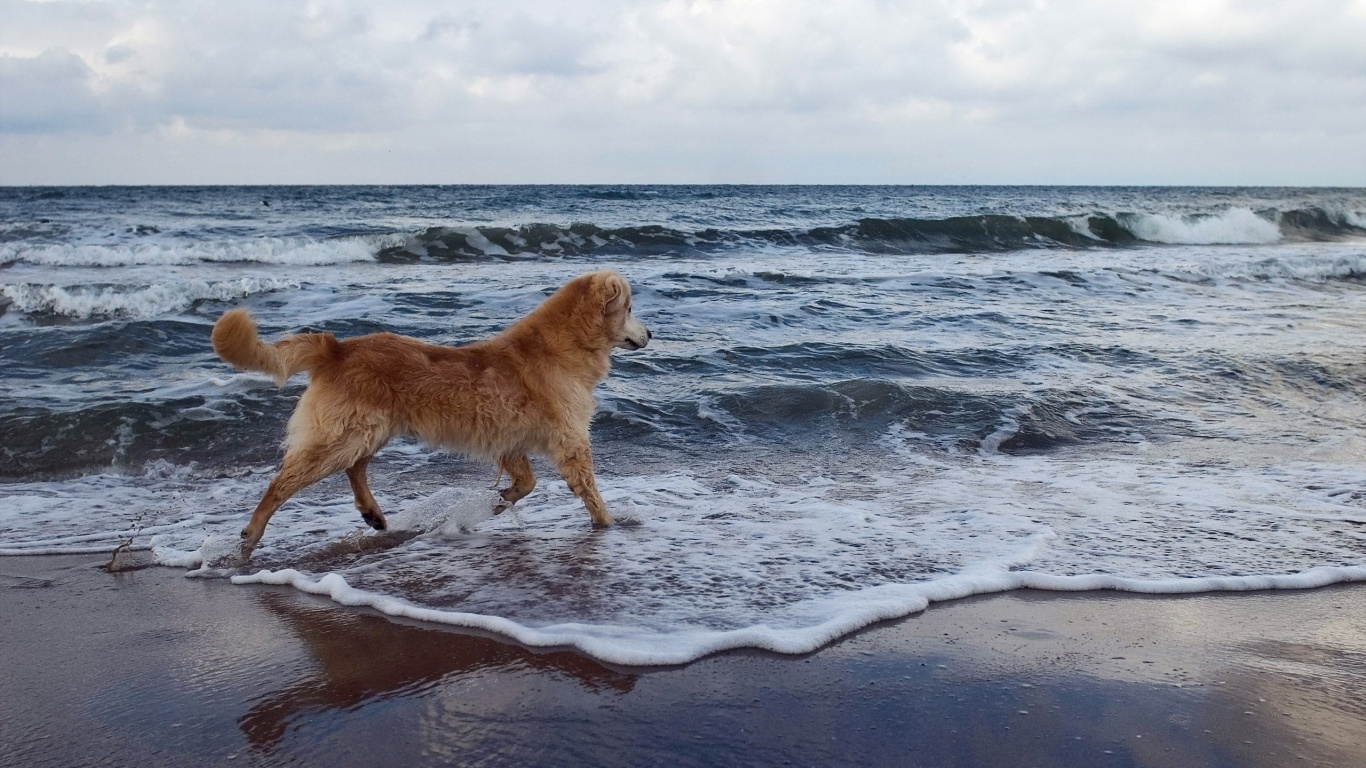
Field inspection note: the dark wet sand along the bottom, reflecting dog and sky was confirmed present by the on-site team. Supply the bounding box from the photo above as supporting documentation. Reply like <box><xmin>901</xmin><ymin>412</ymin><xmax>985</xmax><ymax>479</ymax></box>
<box><xmin>0</xmin><ymin>556</ymin><xmax>1366</xmax><ymax>768</ymax></box>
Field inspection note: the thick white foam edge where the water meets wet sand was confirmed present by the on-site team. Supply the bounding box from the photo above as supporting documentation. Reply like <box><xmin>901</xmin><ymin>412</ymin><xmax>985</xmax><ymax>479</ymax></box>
<box><xmin>231</xmin><ymin>566</ymin><xmax>1366</xmax><ymax>667</ymax></box>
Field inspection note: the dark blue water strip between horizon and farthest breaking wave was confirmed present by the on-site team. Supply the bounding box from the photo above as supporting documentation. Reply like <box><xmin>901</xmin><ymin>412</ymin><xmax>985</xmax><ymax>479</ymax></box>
<box><xmin>8</xmin><ymin>186</ymin><xmax>1366</xmax><ymax>250</ymax></box>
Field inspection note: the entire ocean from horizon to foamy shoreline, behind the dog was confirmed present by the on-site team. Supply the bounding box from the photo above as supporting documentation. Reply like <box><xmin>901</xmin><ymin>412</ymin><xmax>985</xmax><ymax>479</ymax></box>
<box><xmin>0</xmin><ymin>186</ymin><xmax>1366</xmax><ymax>664</ymax></box>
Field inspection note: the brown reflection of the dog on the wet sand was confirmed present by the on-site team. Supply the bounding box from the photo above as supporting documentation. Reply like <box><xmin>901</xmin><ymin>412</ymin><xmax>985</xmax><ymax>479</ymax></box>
<box><xmin>238</xmin><ymin>592</ymin><xmax>637</xmax><ymax>749</ymax></box>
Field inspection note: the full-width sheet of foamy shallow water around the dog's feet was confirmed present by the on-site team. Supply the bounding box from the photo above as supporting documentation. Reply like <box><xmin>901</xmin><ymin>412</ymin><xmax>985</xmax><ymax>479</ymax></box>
<box><xmin>0</xmin><ymin>412</ymin><xmax>1366</xmax><ymax>664</ymax></box>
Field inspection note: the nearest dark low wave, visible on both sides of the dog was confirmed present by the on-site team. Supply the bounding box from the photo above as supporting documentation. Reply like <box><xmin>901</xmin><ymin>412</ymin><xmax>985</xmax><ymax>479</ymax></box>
<box><xmin>0</xmin><ymin>374</ymin><xmax>1136</xmax><ymax>480</ymax></box>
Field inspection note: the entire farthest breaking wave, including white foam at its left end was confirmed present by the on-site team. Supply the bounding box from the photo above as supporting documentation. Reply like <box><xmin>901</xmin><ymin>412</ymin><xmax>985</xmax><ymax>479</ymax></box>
<box><xmin>0</xmin><ymin>206</ymin><xmax>1366</xmax><ymax>266</ymax></box>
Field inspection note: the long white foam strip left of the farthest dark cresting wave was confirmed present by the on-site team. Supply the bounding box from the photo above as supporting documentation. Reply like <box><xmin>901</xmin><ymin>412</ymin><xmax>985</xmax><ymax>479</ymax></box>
<box><xmin>0</xmin><ymin>236</ymin><xmax>391</xmax><ymax>266</ymax></box>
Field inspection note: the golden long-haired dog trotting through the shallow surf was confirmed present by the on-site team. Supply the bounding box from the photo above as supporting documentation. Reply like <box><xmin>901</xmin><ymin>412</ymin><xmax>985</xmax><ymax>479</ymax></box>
<box><xmin>212</xmin><ymin>271</ymin><xmax>653</xmax><ymax>556</ymax></box>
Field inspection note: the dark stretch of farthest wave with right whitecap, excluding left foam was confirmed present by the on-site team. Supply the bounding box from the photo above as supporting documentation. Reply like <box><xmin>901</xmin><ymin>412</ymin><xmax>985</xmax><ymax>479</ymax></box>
<box><xmin>377</xmin><ymin>208</ymin><xmax>1366</xmax><ymax>262</ymax></box>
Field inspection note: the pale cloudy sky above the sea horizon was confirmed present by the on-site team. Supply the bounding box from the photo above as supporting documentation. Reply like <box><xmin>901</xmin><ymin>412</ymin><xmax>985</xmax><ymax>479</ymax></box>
<box><xmin>0</xmin><ymin>0</ymin><xmax>1366</xmax><ymax>186</ymax></box>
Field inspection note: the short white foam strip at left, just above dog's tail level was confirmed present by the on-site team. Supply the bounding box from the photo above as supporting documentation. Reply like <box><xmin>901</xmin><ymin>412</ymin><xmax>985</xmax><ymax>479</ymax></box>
<box><xmin>0</xmin><ymin>277</ymin><xmax>302</xmax><ymax>318</ymax></box>
